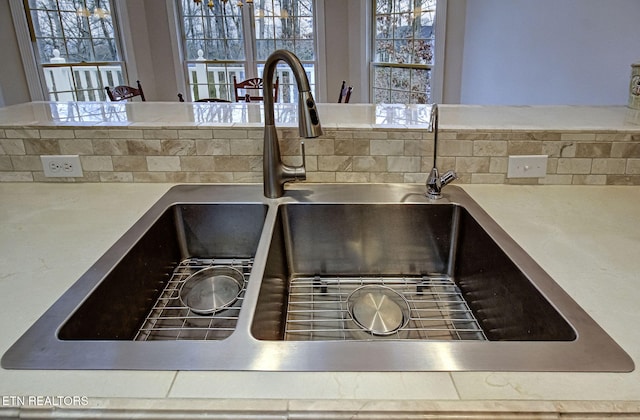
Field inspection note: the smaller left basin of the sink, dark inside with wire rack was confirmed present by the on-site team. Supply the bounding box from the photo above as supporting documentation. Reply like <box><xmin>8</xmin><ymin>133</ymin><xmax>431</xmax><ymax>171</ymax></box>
<box><xmin>58</xmin><ymin>203</ymin><xmax>266</xmax><ymax>340</ymax></box>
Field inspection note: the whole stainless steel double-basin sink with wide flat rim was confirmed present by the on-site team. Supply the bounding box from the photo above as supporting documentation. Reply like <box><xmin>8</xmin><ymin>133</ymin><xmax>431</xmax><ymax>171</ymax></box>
<box><xmin>2</xmin><ymin>184</ymin><xmax>634</xmax><ymax>372</ymax></box>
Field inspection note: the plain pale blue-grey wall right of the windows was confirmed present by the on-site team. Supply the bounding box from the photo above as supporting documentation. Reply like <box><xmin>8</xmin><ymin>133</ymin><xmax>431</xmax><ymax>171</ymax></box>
<box><xmin>460</xmin><ymin>0</ymin><xmax>640</xmax><ymax>105</ymax></box>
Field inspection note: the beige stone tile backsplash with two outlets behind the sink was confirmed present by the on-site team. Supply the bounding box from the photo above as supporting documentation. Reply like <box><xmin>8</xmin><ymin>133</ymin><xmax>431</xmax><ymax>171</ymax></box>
<box><xmin>0</xmin><ymin>126</ymin><xmax>640</xmax><ymax>185</ymax></box>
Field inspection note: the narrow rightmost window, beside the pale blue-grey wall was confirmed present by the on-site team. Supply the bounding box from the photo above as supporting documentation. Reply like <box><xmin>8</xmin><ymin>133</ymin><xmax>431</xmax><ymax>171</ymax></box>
<box><xmin>372</xmin><ymin>0</ymin><xmax>436</xmax><ymax>104</ymax></box>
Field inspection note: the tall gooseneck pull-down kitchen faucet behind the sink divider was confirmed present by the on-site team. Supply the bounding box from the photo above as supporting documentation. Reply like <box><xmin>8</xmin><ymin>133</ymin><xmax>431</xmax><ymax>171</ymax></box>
<box><xmin>262</xmin><ymin>50</ymin><xmax>322</xmax><ymax>198</ymax></box>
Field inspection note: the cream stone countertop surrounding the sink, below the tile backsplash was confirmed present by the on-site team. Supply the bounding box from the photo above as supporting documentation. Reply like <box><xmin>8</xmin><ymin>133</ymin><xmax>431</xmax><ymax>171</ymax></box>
<box><xmin>0</xmin><ymin>183</ymin><xmax>640</xmax><ymax>418</ymax></box>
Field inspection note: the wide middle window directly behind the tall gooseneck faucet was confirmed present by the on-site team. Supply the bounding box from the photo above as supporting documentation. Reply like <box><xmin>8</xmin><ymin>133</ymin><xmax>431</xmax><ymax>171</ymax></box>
<box><xmin>178</xmin><ymin>0</ymin><xmax>317</xmax><ymax>102</ymax></box>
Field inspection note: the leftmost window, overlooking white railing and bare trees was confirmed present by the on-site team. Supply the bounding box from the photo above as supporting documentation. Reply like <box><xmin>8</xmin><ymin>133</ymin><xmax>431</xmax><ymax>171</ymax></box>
<box><xmin>25</xmin><ymin>0</ymin><xmax>124</xmax><ymax>101</ymax></box>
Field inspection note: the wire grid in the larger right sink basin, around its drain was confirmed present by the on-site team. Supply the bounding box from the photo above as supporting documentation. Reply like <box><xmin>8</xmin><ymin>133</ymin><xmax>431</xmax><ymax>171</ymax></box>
<box><xmin>284</xmin><ymin>275</ymin><xmax>487</xmax><ymax>341</ymax></box>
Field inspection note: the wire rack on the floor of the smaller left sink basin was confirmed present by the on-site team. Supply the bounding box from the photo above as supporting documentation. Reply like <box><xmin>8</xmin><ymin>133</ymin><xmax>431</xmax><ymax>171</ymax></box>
<box><xmin>134</xmin><ymin>258</ymin><xmax>253</xmax><ymax>341</ymax></box>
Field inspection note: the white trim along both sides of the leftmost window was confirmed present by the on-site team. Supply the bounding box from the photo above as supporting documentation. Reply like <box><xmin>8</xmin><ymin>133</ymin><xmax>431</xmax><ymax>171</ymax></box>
<box><xmin>9</xmin><ymin>0</ymin><xmax>137</xmax><ymax>101</ymax></box>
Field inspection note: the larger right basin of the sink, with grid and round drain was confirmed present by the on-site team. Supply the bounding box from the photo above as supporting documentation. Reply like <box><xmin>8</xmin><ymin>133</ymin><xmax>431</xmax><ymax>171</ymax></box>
<box><xmin>252</xmin><ymin>203</ymin><xmax>576</xmax><ymax>341</ymax></box>
